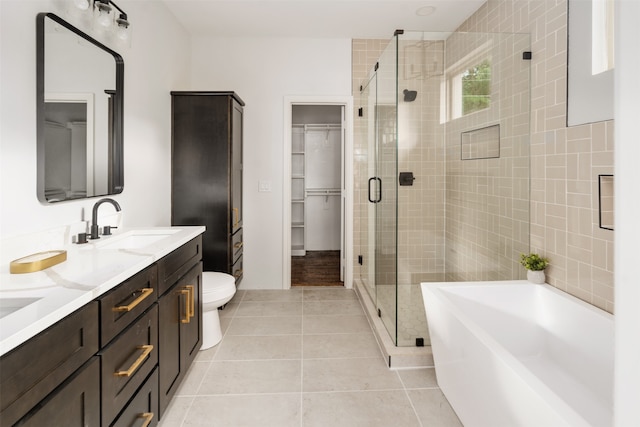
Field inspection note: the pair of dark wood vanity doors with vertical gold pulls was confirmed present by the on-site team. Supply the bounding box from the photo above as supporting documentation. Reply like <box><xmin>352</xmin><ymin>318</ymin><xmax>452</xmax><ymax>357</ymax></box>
<box><xmin>158</xmin><ymin>263</ymin><xmax>202</xmax><ymax>416</ymax></box>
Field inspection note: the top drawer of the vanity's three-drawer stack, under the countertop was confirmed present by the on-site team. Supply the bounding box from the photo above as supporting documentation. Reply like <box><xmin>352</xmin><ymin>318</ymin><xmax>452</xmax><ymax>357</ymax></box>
<box><xmin>99</xmin><ymin>265</ymin><xmax>158</xmax><ymax>347</ymax></box>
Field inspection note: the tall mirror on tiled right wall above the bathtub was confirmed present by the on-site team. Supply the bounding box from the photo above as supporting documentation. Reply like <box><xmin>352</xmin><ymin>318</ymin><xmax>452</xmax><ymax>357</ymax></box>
<box><xmin>567</xmin><ymin>0</ymin><xmax>614</xmax><ymax>126</ymax></box>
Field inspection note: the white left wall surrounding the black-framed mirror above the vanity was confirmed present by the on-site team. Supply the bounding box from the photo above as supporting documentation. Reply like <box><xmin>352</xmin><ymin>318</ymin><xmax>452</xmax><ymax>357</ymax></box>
<box><xmin>0</xmin><ymin>0</ymin><xmax>190</xmax><ymax>238</ymax></box>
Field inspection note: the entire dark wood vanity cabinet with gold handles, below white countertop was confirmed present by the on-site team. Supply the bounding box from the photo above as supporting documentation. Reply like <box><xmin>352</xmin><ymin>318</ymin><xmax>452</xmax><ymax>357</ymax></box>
<box><xmin>0</xmin><ymin>236</ymin><xmax>202</xmax><ymax>427</ymax></box>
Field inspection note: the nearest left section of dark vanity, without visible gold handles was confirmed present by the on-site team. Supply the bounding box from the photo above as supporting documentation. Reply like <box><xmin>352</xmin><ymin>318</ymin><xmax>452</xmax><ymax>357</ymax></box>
<box><xmin>0</xmin><ymin>301</ymin><xmax>100</xmax><ymax>426</ymax></box>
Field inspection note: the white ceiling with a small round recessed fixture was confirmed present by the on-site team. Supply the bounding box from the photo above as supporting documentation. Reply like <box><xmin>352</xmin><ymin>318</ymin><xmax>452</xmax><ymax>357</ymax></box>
<box><xmin>163</xmin><ymin>0</ymin><xmax>485</xmax><ymax>39</ymax></box>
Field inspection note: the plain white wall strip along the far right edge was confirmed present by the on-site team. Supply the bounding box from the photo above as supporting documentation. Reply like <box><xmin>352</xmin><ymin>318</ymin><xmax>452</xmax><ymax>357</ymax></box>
<box><xmin>614</xmin><ymin>0</ymin><xmax>640</xmax><ymax>427</ymax></box>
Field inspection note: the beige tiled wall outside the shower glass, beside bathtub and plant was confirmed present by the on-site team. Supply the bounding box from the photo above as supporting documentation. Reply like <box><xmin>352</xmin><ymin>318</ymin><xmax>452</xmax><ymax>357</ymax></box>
<box><xmin>460</xmin><ymin>0</ymin><xmax>614</xmax><ymax>312</ymax></box>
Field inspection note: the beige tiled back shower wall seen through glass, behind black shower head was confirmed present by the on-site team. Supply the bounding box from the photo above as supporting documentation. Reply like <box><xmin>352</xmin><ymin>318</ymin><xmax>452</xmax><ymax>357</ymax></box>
<box><xmin>398</xmin><ymin>37</ymin><xmax>445</xmax><ymax>284</ymax></box>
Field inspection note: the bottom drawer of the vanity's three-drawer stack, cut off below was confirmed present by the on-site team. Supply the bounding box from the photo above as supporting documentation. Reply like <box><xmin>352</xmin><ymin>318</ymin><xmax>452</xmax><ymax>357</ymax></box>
<box><xmin>112</xmin><ymin>368</ymin><xmax>158</xmax><ymax>427</ymax></box>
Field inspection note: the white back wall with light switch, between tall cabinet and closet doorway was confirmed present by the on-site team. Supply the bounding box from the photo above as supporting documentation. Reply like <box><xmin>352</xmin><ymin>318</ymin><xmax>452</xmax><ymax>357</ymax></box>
<box><xmin>189</xmin><ymin>38</ymin><xmax>351</xmax><ymax>289</ymax></box>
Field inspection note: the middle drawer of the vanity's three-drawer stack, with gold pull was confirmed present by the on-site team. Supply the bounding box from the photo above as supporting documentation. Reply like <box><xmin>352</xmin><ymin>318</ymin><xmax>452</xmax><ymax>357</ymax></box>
<box><xmin>100</xmin><ymin>304</ymin><xmax>158</xmax><ymax>426</ymax></box>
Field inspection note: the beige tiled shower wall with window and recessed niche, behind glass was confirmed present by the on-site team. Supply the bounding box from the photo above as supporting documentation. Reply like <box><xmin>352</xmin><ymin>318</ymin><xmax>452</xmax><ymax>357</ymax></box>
<box><xmin>445</xmin><ymin>32</ymin><xmax>530</xmax><ymax>281</ymax></box>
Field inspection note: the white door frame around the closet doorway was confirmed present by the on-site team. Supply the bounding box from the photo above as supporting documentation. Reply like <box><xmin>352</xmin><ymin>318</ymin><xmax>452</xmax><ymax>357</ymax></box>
<box><xmin>282</xmin><ymin>95</ymin><xmax>353</xmax><ymax>289</ymax></box>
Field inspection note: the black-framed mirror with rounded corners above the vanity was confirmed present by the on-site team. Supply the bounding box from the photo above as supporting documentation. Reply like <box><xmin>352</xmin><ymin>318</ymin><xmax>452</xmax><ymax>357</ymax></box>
<box><xmin>36</xmin><ymin>13</ymin><xmax>124</xmax><ymax>203</ymax></box>
